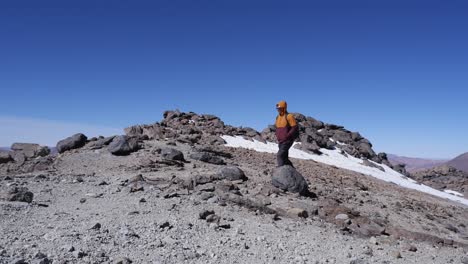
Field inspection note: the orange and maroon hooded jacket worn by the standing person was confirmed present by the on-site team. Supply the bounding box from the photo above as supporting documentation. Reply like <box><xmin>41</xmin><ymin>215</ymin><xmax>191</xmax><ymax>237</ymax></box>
<box><xmin>275</xmin><ymin>101</ymin><xmax>298</xmax><ymax>143</ymax></box>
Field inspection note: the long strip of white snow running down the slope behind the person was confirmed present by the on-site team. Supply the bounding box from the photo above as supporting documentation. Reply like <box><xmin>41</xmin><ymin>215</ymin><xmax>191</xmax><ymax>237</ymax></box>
<box><xmin>222</xmin><ymin>136</ymin><xmax>468</xmax><ymax>205</ymax></box>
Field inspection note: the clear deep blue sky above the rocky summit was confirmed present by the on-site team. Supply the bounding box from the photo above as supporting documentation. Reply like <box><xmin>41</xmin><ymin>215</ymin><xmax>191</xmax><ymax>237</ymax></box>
<box><xmin>0</xmin><ymin>0</ymin><xmax>468</xmax><ymax>158</ymax></box>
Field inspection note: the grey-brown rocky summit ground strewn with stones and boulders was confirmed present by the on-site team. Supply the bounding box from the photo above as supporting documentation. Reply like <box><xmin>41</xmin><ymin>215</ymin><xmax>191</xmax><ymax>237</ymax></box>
<box><xmin>0</xmin><ymin>111</ymin><xmax>468</xmax><ymax>264</ymax></box>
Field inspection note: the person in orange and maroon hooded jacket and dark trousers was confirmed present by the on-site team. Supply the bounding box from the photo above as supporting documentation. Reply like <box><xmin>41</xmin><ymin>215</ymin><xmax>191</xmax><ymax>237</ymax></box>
<box><xmin>275</xmin><ymin>101</ymin><xmax>299</xmax><ymax>167</ymax></box>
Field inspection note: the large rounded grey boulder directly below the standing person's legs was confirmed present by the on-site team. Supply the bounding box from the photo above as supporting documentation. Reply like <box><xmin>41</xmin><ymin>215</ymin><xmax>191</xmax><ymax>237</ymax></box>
<box><xmin>271</xmin><ymin>165</ymin><xmax>309</xmax><ymax>195</ymax></box>
